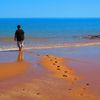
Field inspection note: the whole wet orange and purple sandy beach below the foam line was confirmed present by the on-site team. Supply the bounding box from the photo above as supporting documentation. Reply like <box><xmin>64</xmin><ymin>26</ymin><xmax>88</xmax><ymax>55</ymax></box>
<box><xmin>0</xmin><ymin>46</ymin><xmax>100</xmax><ymax>100</ymax></box>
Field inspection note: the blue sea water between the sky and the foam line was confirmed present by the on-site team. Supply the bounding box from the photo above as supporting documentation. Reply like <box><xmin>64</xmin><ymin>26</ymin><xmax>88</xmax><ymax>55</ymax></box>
<box><xmin>0</xmin><ymin>18</ymin><xmax>100</xmax><ymax>50</ymax></box>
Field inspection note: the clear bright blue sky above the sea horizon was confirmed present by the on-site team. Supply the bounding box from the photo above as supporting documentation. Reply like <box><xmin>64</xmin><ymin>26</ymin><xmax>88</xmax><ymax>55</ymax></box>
<box><xmin>0</xmin><ymin>0</ymin><xmax>100</xmax><ymax>18</ymax></box>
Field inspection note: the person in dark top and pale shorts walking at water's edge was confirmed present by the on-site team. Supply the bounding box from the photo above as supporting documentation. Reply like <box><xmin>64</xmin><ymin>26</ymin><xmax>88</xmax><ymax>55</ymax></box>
<box><xmin>14</xmin><ymin>25</ymin><xmax>24</xmax><ymax>51</ymax></box>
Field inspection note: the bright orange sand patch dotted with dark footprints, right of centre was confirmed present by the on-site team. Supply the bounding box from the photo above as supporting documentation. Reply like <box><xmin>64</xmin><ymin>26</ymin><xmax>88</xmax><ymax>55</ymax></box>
<box><xmin>43</xmin><ymin>55</ymin><xmax>79</xmax><ymax>81</ymax></box>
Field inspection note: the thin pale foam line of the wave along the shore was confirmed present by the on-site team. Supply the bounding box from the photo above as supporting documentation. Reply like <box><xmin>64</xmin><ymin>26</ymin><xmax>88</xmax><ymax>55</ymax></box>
<box><xmin>0</xmin><ymin>42</ymin><xmax>100</xmax><ymax>51</ymax></box>
